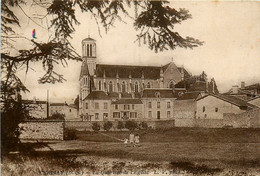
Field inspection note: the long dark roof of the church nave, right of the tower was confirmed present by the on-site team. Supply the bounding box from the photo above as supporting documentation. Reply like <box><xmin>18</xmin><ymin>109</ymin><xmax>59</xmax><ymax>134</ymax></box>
<box><xmin>93</xmin><ymin>63</ymin><xmax>190</xmax><ymax>79</ymax></box>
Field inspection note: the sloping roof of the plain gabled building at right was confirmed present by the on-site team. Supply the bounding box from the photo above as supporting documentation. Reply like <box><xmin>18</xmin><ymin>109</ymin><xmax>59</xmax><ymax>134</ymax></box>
<box><xmin>197</xmin><ymin>94</ymin><xmax>257</xmax><ymax>109</ymax></box>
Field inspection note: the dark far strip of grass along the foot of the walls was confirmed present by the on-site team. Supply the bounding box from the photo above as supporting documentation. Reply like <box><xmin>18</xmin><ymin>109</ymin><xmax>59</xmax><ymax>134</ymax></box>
<box><xmin>77</xmin><ymin>128</ymin><xmax>260</xmax><ymax>143</ymax></box>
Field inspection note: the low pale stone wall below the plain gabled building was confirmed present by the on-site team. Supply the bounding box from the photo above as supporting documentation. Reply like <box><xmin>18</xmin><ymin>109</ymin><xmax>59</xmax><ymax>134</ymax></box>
<box><xmin>175</xmin><ymin>118</ymin><xmax>224</xmax><ymax>128</ymax></box>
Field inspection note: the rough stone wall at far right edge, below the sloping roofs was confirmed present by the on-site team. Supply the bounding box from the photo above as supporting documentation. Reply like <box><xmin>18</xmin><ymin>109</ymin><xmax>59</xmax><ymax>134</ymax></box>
<box><xmin>223</xmin><ymin>109</ymin><xmax>260</xmax><ymax>128</ymax></box>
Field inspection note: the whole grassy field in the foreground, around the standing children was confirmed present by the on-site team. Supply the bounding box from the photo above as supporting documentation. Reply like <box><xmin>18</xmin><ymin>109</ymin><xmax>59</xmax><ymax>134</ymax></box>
<box><xmin>3</xmin><ymin>128</ymin><xmax>260</xmax><ymax>175</ymax></box>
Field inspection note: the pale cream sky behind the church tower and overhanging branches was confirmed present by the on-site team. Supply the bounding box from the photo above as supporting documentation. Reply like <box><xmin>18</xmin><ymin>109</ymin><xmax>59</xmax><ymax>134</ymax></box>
<box><xmin>12</xmin><ymin>2</ymin><xmax>260</xmax><ymax>102</ymax></box>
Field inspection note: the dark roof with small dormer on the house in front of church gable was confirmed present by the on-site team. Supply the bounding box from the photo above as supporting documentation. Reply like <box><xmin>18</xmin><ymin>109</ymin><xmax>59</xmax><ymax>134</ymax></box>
<box><xmin>142</xmin><ymin>89</ymin><xmax>184</xmax><ymax>98</ymax></box>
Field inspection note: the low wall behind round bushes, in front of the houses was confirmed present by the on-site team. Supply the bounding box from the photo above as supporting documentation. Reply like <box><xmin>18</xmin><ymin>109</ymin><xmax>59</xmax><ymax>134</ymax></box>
<box><xmin>65</xmin><ymin>120</ymin><xmax>175</xmax><ymax>131</ymax></box>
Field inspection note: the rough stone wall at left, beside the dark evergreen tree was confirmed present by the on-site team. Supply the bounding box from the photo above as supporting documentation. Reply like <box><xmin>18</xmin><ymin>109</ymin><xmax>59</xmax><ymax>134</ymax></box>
<box><xmin>19</xmin><ymin>121</ymin><xmax>64</xmax><ymax>140</ymax></box>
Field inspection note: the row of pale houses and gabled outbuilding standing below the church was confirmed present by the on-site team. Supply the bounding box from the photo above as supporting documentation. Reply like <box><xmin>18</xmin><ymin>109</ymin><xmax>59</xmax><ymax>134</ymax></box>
<box><xmin>83</xmin><ymin>88</ymin><xmax>260</xmax><ymax>121</ymax></box>
